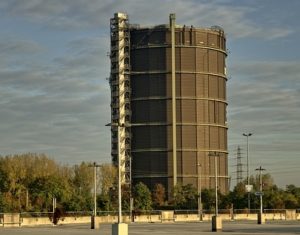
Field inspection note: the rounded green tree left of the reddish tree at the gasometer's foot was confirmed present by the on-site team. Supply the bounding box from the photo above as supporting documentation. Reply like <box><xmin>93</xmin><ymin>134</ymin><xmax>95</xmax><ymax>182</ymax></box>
<box><xmin>133</xmin><ymin>182</ymin><xmax>152</xmax><ymax>211</ymax></box>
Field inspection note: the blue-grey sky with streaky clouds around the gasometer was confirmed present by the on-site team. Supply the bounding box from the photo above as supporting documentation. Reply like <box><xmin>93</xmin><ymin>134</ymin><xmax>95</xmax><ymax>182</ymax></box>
<box><xmin>0</xmin><ymin>0</ymin><xmax>300</xmax><ymax>187</ymax></box>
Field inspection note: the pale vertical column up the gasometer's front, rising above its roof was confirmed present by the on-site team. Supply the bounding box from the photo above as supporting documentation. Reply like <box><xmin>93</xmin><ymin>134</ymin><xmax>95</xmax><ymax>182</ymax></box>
<box><xmin>170</xmin><ymin>13</ymin><xmax>177</xmax><ymax>186</ymax></box>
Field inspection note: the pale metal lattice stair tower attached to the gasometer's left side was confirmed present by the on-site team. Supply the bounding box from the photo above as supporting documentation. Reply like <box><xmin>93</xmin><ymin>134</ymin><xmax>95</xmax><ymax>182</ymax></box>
<box><xmin>110</xmin><ymin>13</ymin><xmax>131</xmax><ymax>183</ymax></box>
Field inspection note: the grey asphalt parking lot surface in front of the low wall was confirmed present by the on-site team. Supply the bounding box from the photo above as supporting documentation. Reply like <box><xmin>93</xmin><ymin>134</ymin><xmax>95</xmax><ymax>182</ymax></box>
<box><xmin>0</xmin><ymin>221</ymin><xmax>300</xmax><ymax>235</ymax></box>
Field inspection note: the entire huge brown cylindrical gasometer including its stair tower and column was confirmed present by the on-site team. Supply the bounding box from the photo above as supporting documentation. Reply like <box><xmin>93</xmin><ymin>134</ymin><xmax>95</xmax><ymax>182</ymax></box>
<box><xmin>110</xmin><ymin>13</ymin><xmax>228</xmax><ymax>196</ymax></box>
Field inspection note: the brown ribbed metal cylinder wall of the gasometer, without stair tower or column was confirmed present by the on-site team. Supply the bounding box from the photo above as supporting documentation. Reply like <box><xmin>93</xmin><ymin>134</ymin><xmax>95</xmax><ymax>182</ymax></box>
<box><xmin>126</xmin><ymin>26</ymin><xmax>228</xmax><ymax>195</ymax></box>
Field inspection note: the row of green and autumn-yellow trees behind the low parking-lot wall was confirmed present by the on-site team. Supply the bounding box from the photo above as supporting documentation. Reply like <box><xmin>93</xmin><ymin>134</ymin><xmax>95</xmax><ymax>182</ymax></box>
<box><xmin>0</xmin><ymin>153</ymin><xmax>300</xmax><ymax>213</ymax></box>
